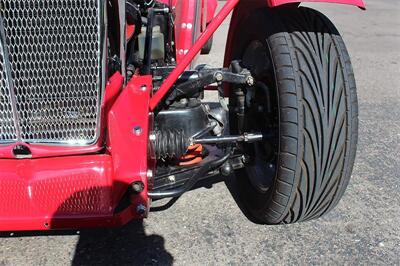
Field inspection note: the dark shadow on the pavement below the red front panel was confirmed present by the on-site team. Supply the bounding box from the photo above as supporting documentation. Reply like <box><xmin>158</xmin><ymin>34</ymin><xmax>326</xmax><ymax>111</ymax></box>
<box><xmin>72</xmin><ymin>221</ymin><xmax>174</xmax><ymax>265</ymax></box>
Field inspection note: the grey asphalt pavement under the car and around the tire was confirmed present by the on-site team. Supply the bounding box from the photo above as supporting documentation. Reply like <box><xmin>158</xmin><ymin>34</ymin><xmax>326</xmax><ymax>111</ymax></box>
<box><xmin>0</xmin><ymin>0</ymin><xmax>400</xmax><ymax>265</ymax></box>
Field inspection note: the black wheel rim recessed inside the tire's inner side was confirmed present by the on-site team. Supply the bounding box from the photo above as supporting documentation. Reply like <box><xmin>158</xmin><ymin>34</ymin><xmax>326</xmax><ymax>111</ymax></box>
<box><xmin>242</xmin><ymin>40</ymin><xmax>279</xmax><ymax>193</ymax></box>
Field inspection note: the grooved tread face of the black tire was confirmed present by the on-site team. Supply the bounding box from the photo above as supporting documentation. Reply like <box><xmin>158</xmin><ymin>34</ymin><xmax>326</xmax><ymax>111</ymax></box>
<box><xmin>262</xmin><ymin>8</ymin><xmax>358</xmax><ymax>224</ymax></box>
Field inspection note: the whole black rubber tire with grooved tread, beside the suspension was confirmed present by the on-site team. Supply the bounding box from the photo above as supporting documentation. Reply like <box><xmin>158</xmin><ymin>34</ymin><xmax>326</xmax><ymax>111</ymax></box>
<box><xmin>230</xmin><ymin>5</ymin><xmax>358</xmax><ymax>224</ymax></box>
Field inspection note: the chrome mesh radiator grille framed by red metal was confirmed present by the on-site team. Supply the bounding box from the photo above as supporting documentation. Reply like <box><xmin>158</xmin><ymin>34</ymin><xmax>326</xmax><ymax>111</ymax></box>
<box><xmin>0</xmin><ymin>0</ymin><xmax>104</xmax><ymax>145</ymax></box>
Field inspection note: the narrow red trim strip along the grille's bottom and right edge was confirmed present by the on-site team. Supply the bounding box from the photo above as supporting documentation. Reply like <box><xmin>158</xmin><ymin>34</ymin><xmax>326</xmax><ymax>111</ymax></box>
<box><xmin>0</xmin><ymin>73</ymin><xmax>123</xmax><ymax>159</ymax></box>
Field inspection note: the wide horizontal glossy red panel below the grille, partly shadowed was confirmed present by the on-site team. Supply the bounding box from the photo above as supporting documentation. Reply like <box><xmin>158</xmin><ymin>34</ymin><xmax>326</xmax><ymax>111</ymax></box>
<box><xmin>0</xmin><ymin>155</ymin><xmax>114</xmax><ymax>230</ymax></box>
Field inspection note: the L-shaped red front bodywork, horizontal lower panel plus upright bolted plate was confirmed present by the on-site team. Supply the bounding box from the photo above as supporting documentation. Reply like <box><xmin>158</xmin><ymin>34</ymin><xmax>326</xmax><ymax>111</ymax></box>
<box><xmin>0</xmin><ymin>75</ymin><xmax>154</xmax><ymax>231</ymax></box>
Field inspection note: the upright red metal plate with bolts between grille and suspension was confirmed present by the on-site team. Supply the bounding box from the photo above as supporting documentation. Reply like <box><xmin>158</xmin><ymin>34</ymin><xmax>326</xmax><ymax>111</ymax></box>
<box><xmin>107</xmin><ymin>76</ymin><xmax>152</xmax><ymax>206</ymax></box>
